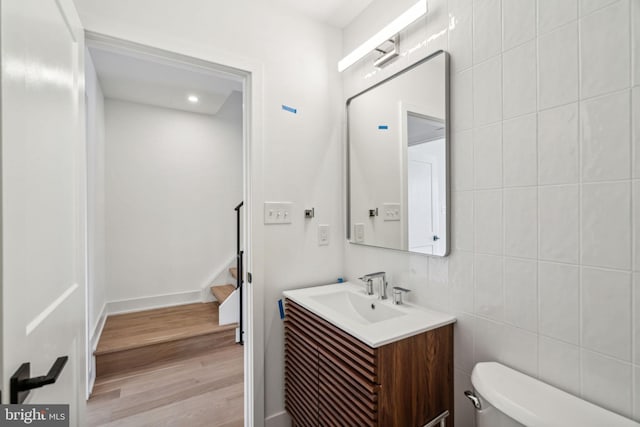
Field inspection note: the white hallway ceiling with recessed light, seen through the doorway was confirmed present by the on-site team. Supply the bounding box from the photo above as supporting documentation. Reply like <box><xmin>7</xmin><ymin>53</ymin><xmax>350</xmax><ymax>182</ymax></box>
<box><xmin>89</xmin><ymin>47</ymin><xmax>242</xmax><ymax>115</ymax></box>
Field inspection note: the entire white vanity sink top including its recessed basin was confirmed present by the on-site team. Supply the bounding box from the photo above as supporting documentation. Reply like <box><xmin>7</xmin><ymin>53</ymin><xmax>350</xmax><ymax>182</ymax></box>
<box><xmin>284</xmin><ymin>282</ymin><xmax>456</xmax><ymax>348</ymax></box>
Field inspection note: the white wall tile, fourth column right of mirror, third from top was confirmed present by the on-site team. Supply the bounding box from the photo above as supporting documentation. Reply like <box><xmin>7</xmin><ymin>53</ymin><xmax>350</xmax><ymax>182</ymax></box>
<box><xmin>538</xmin><ymin>103</ymin><xmax>580</xmax><ymax>185</ymax></box>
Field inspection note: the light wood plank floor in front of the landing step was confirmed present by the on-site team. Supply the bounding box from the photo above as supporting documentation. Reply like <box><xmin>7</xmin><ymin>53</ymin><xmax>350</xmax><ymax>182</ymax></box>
<box><xmin>87</xmin><ymin>345</ymin><xmax>244</xmax><ymax>427</ymax></box>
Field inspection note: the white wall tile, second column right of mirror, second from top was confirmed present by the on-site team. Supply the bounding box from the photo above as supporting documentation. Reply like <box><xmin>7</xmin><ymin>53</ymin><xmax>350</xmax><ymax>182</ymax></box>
<box><xmin>473</xmin><ymin>56</ymin><xmax>502</xmax><ymax>127</ymax></box>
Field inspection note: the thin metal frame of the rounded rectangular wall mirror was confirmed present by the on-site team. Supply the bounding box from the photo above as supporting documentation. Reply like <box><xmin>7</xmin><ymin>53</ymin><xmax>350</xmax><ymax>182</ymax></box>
<box><xmin>345</xmin><ymin>50</ymin><xmax>451</xmax><ymax>258</ymax></box>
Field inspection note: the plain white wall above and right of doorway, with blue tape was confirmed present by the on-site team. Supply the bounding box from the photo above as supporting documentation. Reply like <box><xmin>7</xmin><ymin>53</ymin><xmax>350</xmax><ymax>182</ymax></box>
<box><xmin>76</xmin><ymin>0</ymin><xmax>344</xmax><ymax>425</ymax></box>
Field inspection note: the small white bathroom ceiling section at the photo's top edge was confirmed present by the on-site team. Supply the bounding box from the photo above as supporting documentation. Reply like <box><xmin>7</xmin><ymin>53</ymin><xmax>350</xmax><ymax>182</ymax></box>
<box><xmin>277</xmin><ymin>0</ymin><xmax>373</xmax><ymax>28</ymax></box>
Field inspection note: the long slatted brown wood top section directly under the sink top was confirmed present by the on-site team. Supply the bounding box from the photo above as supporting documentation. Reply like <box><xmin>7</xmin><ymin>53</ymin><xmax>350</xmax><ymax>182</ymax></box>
<box><xmin>287</xmin><ymin>300</ymin><xmax>378</xmax><ymax>383</ymax></box>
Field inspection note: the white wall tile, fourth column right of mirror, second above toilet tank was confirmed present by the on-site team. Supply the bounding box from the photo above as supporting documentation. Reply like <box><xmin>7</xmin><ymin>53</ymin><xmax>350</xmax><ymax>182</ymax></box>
<box><xmin>538</xmin><ymin>262</ymin><xmax>580</xmax><ymax>345</ymax></box>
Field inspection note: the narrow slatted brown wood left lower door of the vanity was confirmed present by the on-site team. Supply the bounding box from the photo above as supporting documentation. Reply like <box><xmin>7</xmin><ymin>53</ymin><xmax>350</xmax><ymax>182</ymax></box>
<box><xmin>285</xmin><ymin>316</ymin><xmax>318</xmax><ymax>426</ymax></box>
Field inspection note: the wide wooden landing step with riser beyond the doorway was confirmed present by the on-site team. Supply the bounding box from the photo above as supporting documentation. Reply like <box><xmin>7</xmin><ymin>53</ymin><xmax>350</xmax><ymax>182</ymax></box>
<box><xmin>94</xmin><ymin>303</ymin><xmax>236</xmax><ymax>377</ymax></box>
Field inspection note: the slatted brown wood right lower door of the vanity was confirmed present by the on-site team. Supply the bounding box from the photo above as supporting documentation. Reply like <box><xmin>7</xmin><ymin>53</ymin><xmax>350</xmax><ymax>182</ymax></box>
<box><xmin>318</xmin><ymin>354</ymin><xmax>379</xmax><ymax>426</ymax></box>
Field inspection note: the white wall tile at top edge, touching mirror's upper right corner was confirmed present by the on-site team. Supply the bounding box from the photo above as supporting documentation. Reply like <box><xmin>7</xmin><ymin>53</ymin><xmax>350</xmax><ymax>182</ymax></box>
<box><xmin>449</xmin><ymin>0</ymin><xmax>473</xmax><ymax>71</ymax></box>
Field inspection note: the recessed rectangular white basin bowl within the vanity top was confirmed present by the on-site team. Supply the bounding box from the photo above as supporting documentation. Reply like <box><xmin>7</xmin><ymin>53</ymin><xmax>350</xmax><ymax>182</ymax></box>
<box><xmin>311</xmin><ymin>290</ymin><xmax>407</xmax><ymax>324</ymax></box>
